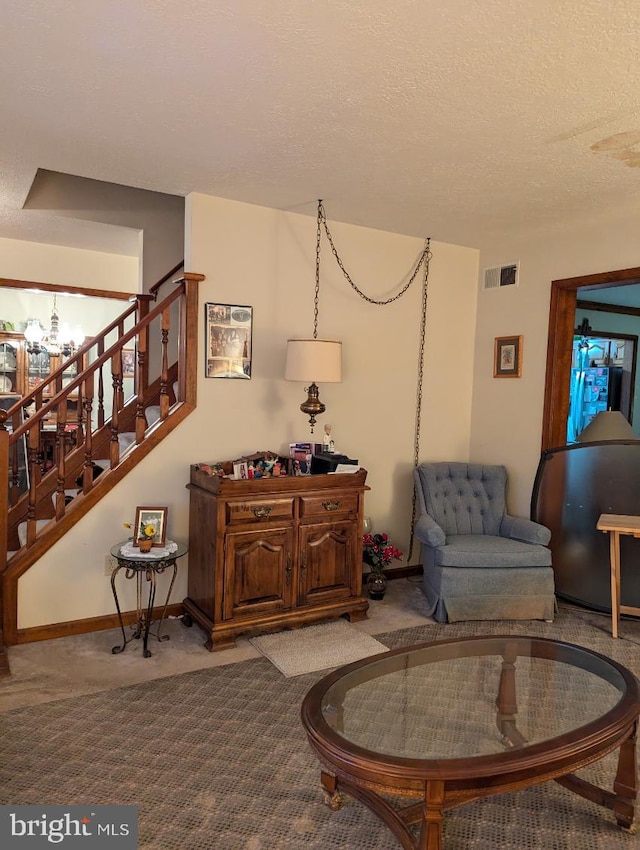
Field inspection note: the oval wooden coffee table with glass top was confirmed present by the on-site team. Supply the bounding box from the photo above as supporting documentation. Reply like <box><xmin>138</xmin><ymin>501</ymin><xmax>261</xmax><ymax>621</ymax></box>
<box><xmin>301</xmin><ymin>635</ymin><xmax>640</xmax><ymax>850</ymax></box>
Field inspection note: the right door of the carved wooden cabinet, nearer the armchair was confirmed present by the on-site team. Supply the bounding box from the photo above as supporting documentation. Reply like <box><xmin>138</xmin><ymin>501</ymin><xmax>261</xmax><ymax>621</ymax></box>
<box><xmin>299</xmin><ymin>521</ymin><xmax>361</xmax><ymax>605</ymax></box>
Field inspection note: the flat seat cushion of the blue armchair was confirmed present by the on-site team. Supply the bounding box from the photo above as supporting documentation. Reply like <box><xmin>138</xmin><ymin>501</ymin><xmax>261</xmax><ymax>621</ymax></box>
<box><xmin>433</xmin><ymin>534</ymin><xmax>551</xmax><ymax>569</ymax></box>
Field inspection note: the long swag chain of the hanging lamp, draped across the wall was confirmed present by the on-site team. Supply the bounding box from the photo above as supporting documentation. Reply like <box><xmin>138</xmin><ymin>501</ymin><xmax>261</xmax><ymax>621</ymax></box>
<box><xmin>313</xmin><ymin>200</ymin><xmax>432</xmax><ymax>561</ymax></box>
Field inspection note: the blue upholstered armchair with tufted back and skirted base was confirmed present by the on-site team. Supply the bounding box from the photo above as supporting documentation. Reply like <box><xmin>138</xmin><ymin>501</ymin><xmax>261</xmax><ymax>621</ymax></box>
<box><xmin>414</xmin><ymin>463</ymin><xmax>555</xmax><ymax>622</ymax></box>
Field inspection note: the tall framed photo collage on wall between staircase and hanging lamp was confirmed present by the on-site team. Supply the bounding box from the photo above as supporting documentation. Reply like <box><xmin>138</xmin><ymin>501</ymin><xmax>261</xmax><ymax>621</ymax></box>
<box><xmin>204</xmin><ymin>303</ymin><xmax>253</xmax><ymax>381</ymax></box>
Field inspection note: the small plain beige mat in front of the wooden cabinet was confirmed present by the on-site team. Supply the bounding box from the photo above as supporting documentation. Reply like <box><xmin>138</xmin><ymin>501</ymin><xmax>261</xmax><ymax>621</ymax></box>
<box><xmin>250</xmin><ymin>620</ymin><xmax>388</xmax><ymax>678</ymax></box>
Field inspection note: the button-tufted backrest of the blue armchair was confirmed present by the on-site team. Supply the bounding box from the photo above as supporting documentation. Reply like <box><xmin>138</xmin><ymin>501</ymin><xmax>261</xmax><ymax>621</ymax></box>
<box><xmin>417</xmin><ymin>463</ymin><xmax>507</xmax><ymax>536</ymax></box>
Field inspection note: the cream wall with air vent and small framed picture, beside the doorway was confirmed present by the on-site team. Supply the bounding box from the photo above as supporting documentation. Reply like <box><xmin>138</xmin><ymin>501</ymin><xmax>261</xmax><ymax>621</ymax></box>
<box><xmin>471</xmin><ymin>200</ymin><xmax>640</xmax><ymax>516</ymax></box>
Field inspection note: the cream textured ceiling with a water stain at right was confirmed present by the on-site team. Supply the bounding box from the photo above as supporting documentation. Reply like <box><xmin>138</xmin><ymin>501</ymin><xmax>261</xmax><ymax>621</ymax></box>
<box><xmin>0</xmin><ymin>0</ymin><xmax>640</xmax><ymax>250</ymax></box>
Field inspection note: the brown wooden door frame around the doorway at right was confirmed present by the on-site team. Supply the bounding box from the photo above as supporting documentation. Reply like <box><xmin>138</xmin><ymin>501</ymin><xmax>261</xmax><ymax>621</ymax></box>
<box><xmin>542</xmin><ymin>267</ymin><xmax>640</xmax><ymax>451</ymax></box>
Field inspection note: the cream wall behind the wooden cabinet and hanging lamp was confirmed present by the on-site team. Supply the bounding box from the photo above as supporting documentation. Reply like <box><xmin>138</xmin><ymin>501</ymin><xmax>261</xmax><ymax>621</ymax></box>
<box><xmin>18</xmin><ymin>194</ymin><xmax>478</xmax><ymax>628</ymax></box>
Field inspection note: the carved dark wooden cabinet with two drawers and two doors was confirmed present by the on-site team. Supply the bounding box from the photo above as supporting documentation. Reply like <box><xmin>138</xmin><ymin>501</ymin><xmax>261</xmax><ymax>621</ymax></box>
<box><xmin>184</xmin><ymin>466</ymin><xmax>369</xmax><ymax>650</ymax></box>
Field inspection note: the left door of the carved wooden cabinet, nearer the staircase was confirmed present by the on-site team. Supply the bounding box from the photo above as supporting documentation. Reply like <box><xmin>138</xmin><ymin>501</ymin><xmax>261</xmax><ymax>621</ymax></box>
<box><xmin>223</xmin><ymin>528</ymin><xmax>293</xmax><ymax>620</ymax></box>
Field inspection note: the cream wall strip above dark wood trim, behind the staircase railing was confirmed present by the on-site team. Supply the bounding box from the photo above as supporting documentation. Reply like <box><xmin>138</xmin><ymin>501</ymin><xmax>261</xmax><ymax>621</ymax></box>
<box><xmin>0</xmin><ymin>239</ymin><xmax>139</xmax><ymax>292</ymax></box>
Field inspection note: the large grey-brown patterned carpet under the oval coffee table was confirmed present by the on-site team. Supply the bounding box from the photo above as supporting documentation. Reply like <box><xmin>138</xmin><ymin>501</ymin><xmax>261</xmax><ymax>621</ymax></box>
<box><xmin>0</xmin><ymin>609</ymin><xmax>640</xmax><ymax>850</ymax></box>
